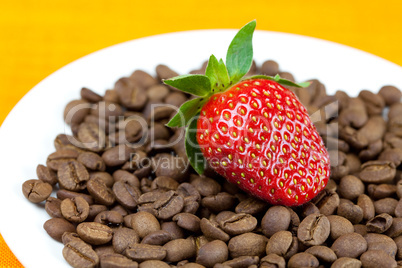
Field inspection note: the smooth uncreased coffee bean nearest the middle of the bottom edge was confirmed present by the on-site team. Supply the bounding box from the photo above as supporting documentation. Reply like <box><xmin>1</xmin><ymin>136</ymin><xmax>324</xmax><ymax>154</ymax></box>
<box><xmin>196</xmin><ymin>240</ymin><xmax>229</xmax><ymax>267</ymax></box>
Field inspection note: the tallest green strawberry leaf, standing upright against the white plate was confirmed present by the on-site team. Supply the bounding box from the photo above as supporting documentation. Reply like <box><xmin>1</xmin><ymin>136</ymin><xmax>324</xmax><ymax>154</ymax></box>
<box><xmin>226</xmin><ymin>20</ymin><xmax>256</xmax><ymax>84</ymax></box>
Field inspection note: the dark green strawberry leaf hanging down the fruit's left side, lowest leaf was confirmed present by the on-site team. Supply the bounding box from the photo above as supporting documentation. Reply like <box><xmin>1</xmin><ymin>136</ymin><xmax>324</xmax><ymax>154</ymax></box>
<box><xmin>185</xmin><ymin>113</ymin><xmax>206</xmax><ymax>175</ymax></box>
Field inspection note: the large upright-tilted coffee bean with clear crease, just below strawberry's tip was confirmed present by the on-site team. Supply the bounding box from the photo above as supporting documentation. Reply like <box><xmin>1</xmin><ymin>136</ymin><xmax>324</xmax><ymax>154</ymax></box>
<box><xmin>297</xmin><ymin>214</ymin><xmax>331</xmax><ymax>246</ymax></box>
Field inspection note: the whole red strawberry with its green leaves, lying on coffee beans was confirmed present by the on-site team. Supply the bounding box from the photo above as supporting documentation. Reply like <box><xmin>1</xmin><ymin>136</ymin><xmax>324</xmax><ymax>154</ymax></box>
<box><xmin>164</xmin><ymin>21</ymin><xmax>330</xmax><ymax>206</ymax></box>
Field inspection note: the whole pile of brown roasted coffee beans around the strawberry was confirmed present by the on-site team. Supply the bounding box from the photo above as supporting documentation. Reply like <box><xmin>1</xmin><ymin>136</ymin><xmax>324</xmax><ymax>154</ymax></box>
<box><xmin>22</xmin><ymin>61</ymin><xmax>402</xmax><ymax>268</ymax></box>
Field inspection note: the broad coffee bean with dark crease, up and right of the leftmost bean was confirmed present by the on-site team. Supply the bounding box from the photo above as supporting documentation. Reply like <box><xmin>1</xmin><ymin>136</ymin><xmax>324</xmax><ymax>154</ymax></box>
<box><xmin>57</xmin><ymin>160</ymin><xmax>89</xmax><ymax>192</ymax></box>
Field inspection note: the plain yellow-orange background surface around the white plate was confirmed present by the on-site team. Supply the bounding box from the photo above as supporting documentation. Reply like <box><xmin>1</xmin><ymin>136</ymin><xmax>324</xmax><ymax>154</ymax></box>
<box><xmin>0</xmin><ymin>0</ymin><xmax>402</xmax><ymax>267</ymax></box>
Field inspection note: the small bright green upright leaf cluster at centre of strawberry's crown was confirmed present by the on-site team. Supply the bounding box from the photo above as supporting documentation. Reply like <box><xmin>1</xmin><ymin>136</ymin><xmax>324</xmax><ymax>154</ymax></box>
<box><xmin>205</xmin><ymin>55</ymin><xmax>230</xmax><ymax>93</ymax></box>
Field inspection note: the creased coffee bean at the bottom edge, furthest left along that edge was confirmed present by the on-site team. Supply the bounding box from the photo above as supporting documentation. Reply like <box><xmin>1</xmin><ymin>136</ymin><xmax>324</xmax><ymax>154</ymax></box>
<box><xmin>63</xmin><ymin>239</ymin><xmax>99</xmax><ymax>268</ymax></box>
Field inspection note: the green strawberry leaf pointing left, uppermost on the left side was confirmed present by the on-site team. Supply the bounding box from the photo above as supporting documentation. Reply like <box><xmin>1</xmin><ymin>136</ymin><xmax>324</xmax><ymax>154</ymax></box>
<box><xmin>163</xmin><ymin>74</ymin><xmax>211</xmax><ymax>97</ymax></box>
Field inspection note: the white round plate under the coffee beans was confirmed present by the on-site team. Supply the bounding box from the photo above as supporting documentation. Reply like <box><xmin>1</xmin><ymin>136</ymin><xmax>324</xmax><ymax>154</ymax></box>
<box><xmin>0</xmin><ymin>30</ymin><xmax>402</xmax><ymax>268</ymax></box>
